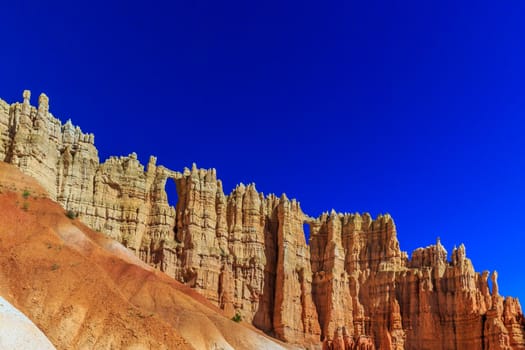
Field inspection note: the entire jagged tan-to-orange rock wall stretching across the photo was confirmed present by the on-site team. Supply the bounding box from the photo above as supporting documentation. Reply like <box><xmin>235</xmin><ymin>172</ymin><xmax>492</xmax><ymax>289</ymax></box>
<box><xmin>0</xmin><ymin>92</ymin><xmax>525</xmax><ymax>350</ymax></box>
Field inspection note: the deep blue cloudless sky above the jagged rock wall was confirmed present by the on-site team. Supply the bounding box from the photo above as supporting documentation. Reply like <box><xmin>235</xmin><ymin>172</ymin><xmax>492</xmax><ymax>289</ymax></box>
<box><xmin>0</xmin><ymin>0</ymin><xmax>525</xmax><ymax>301</ymax></box>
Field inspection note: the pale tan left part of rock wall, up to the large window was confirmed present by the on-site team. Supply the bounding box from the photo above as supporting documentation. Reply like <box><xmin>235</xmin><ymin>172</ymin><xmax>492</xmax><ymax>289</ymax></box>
<box><xmin>0</xmin><ymin>90</ymin><xmax>176</xmax><ymax>256</ymax></box>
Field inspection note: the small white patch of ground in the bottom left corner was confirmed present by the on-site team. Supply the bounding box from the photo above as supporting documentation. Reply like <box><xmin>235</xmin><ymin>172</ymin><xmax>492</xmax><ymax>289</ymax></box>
<box><xmin>0</xmin><ymin>297</ymin><xmax>55</xmax><ymax>350</ymax></box>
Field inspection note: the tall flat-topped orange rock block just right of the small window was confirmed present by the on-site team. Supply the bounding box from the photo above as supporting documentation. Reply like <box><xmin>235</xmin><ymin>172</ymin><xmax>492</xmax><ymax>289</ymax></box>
<box><xmin>310</xmin><ymin>211</ymin><xmax>407</xmax><ymax>348</ymax></box>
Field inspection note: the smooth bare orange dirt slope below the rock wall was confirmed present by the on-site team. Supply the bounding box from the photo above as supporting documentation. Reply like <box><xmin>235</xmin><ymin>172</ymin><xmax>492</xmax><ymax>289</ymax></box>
<box><xmin>0</xmin><ymin>162</ymin><xmax>296</xmax><ymax>350</ymax></box>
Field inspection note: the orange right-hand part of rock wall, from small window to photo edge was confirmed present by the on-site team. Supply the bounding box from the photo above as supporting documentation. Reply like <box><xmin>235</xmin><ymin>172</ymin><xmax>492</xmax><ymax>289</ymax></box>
<box><xmin>310</xmin><ymin>212</ymin><xmax>525</xmax><ymax>349</ymax></box>
